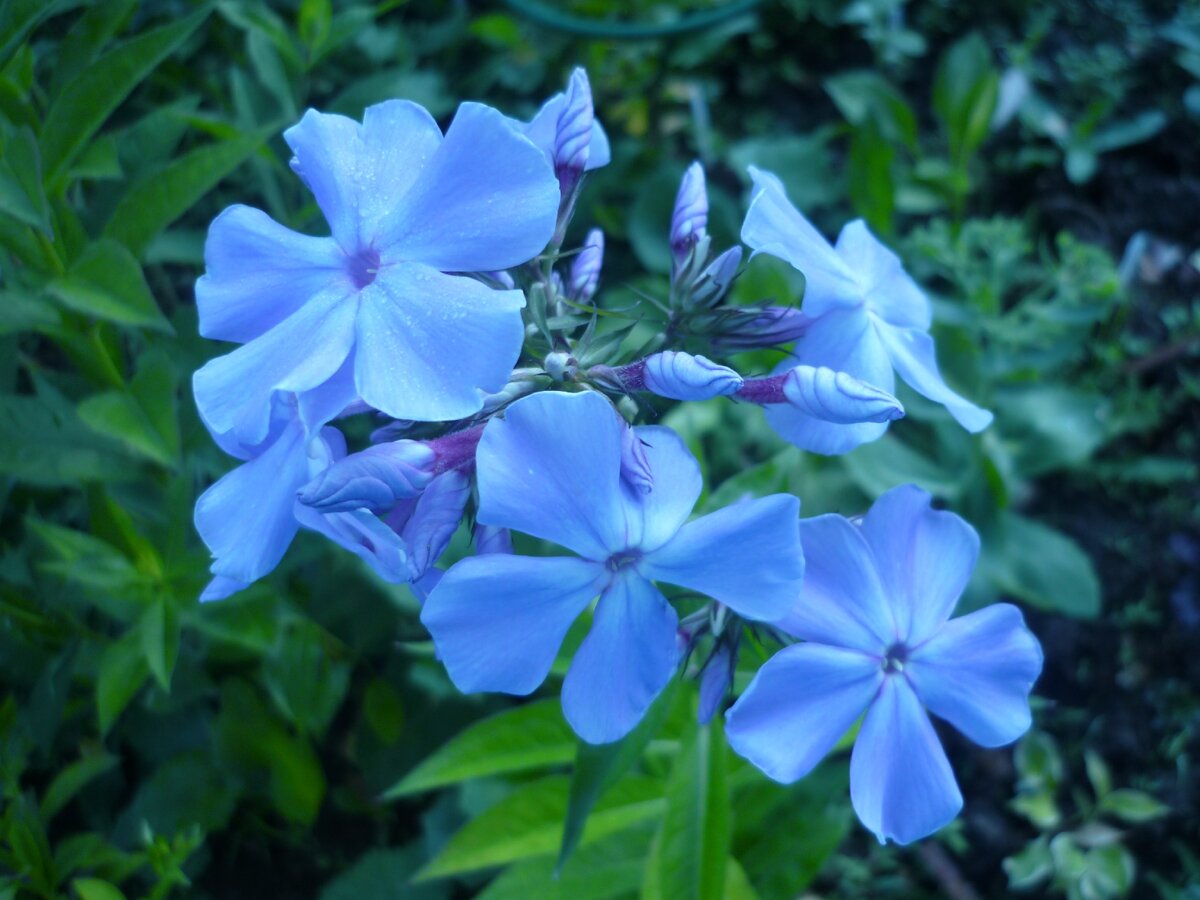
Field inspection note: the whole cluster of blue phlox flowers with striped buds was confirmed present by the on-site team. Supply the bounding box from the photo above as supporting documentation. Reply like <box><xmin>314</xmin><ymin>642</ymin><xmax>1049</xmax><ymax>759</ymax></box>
<box><xmin>194</xmin><ymin>70</ymin><xmax>1042</xmax><ymax>842</ymax></box>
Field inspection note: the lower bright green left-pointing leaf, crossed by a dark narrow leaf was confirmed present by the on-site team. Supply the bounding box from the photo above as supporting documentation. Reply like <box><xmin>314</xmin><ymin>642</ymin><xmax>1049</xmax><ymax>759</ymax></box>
<box><xmin>415</xmin><ymin>775</ymin><xmax>664</xmax><ymax>881</ymax></box>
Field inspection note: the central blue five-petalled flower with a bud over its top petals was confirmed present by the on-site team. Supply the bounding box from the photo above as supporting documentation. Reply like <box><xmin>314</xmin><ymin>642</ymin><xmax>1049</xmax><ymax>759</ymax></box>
<box><xmin>421</xmin><ymin>392</ymin><xmax>804</xmax><ymax>743</ymax></box>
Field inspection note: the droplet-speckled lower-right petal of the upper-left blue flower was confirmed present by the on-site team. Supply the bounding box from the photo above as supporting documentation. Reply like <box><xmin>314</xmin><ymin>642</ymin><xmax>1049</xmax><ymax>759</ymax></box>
<box><xmin>354</xmin><ymin>263</ymin><xmax>524</xmax><ymax>421</ymax></box>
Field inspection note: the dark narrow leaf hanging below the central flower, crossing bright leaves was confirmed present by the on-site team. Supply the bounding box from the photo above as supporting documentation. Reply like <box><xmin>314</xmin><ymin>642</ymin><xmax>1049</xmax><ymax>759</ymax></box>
<box><xmin>558</xmin><ymin>679</ymin><xmax>679</xmax><ymax>866</ymax></box>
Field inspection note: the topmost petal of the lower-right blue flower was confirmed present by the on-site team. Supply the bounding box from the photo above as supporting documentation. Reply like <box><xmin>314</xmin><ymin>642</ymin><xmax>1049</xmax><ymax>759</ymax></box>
<box><xmin>862</xmin><ymin>485</ymin><xmax>979</xmax><ymax>647</ymax></box>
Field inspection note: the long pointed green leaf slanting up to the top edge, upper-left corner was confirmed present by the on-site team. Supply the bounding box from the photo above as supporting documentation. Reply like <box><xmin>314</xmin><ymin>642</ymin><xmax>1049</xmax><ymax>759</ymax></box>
<box><xmin>42</xmin><ymin>7</ymin><xmax>209</xmax><ymax>185</ymax></box>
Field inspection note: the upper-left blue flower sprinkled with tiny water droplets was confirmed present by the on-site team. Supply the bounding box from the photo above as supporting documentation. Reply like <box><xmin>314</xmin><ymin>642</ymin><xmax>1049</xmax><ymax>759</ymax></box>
<box><xmin>194</xmin><ymin>101</ymin><xmax>558</xmax><ymax>444</ymax></box>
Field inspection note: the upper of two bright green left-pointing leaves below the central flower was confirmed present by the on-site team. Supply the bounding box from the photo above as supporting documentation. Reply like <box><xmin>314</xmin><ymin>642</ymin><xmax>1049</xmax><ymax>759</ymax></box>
<box><xmin>383</xmin><ymin>697</ymin><xmax>576</xmax><ymax>800</ymax></box>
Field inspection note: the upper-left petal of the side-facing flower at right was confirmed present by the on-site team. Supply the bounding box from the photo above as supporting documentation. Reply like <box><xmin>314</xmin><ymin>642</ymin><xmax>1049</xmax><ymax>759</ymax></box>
<box><xmin>742</xmin><ymin>166</ymin><xmax>864</xmax><ymax>319</ymax></box>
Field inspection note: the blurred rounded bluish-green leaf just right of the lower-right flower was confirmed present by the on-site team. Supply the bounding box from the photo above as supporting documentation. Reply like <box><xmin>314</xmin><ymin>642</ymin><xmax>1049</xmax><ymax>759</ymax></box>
<box><xmin>979</xmin><ymin>510</ymin><xmax>1100</xmax><ymax>618</ymax></box>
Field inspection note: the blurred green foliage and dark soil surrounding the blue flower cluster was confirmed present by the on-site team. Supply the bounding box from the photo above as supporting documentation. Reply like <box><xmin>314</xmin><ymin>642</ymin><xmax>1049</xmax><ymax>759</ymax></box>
<box><xmin>0</xmin><ymin>0</ymin><xmax>1200</xmax><ymax>900</ymax></box>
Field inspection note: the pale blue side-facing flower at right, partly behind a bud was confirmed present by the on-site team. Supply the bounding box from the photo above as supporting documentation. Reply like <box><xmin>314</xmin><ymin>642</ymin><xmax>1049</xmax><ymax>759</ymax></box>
<box><xmin>742</xmin><ymin>167</ymin><xmax>992</xmax><ymax>454</ymax></box>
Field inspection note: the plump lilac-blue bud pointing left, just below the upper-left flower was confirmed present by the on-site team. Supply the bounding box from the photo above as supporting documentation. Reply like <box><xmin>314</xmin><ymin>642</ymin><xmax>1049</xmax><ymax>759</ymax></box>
<box><xmin>298</xmin><ymin>440</ymin><xmax>436</xmax><ymax>512</ymax></box>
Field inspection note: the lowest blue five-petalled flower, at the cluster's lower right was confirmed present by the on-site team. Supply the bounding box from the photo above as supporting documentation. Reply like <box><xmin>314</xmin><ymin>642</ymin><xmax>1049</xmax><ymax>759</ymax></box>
<box><xmin>727</xmin><ymin>485</ymin><xmax>1042</xmax><ymax>844</ymax></box>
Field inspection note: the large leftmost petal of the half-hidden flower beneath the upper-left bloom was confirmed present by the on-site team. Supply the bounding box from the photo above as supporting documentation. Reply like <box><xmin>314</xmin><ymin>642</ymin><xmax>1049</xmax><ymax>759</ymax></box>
<box><xmin>196</xmin><ymin>422</ymin><xmax>308</xmax><ymax>584</ymax></box>
